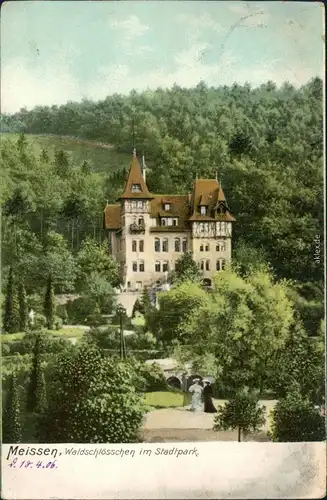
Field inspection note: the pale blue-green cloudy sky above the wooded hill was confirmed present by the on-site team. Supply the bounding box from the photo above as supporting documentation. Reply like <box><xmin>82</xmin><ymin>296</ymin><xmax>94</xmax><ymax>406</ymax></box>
<box><xmin>1</xmin><ymin>0</ymin><xmax>324</xmax><ymax>113</ymax></box>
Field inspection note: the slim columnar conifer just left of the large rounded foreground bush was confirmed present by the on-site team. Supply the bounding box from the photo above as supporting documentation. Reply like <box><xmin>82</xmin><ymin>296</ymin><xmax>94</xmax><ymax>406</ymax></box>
<box><xmin>27</xmin><ymin>334</ymin><xmax>46</xmax><ymax>414</ymax></box>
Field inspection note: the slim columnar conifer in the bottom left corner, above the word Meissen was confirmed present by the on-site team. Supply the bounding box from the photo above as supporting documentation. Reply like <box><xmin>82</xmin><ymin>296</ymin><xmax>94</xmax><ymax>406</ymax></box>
<box><xmin>2</xmin><ymin>373</ymin><xmax>22</xmax><ymax>443</ymax></box>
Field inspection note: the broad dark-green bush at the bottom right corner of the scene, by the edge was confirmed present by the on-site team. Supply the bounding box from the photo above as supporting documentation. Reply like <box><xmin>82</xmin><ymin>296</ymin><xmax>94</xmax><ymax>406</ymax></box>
<box><xmin>270</xmin><ymin>390</ymin><xmax>326</xmax><ymax>442</ymax></box>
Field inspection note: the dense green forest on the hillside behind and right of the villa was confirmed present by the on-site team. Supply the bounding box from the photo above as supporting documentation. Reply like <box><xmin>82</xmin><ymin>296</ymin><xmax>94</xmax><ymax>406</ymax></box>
<box><xmin>1</xmin><ymin>78</ymin><xmax>323</xmax><ymax>290</ymax></box>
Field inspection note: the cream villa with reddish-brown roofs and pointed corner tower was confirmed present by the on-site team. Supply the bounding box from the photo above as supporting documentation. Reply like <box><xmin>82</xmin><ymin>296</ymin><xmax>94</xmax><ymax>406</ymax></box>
<box><xmin>104</xmin><ymin>150</ymin><xmax>235</xmax><ymax>290</ymax></box>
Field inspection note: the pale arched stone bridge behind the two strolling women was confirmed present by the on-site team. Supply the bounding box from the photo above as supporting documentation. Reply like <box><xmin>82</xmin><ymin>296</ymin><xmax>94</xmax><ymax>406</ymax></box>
<box><xmin>146</xmin><ymin>358</ymin><xmax>214</xmax><ymax>392</ymax></box>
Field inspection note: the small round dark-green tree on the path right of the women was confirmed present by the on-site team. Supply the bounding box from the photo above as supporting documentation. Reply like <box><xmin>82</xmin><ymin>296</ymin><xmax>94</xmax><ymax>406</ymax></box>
<box><xmin>213</xmin><ymin>392</ymin><xmax>266</xmax><ymax>443</ymax></box>
